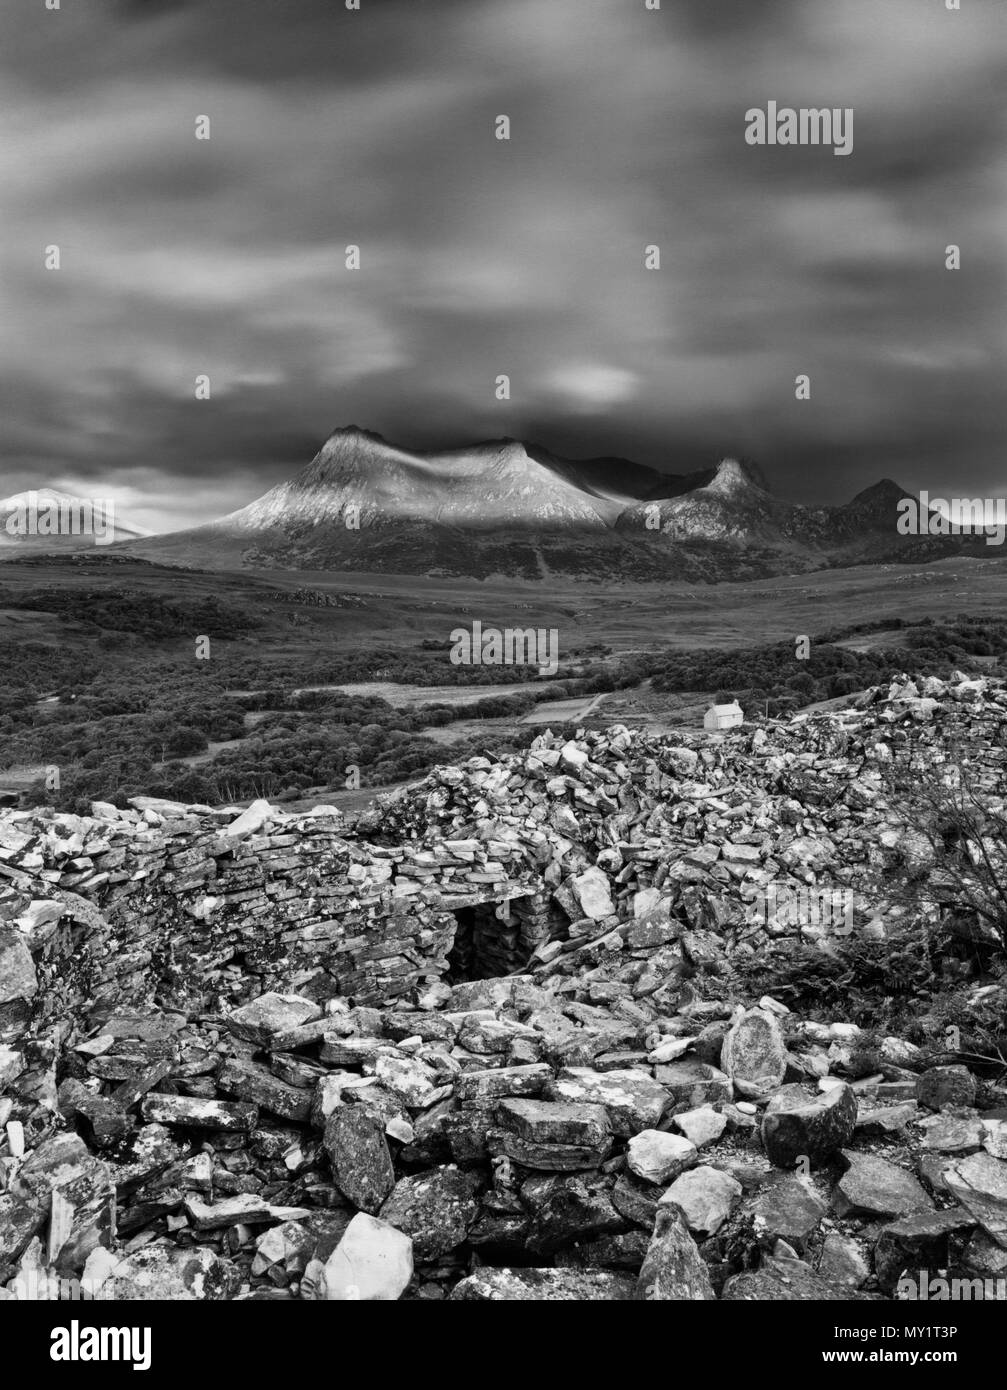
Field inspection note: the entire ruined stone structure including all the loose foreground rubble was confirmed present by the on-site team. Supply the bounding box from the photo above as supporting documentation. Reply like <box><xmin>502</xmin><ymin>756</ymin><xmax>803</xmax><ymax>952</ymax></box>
<box><xmin>0</xmin><ymin>676</ymin><xmax>1007</xmax><ymax>1301</ymax></box>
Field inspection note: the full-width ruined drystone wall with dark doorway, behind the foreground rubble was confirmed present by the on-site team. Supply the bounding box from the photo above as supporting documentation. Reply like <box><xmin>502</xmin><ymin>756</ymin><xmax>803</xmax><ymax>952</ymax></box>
<box><xmin>0</xmin><ymin>677</ymin><xmax>1007</xmax><ymax>1050</ymax></box>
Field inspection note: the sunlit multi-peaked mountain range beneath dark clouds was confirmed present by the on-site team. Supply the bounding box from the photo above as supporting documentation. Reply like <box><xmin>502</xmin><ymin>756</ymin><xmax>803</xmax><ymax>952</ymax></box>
<box><xmin>0</xmin><ymin>425</ymin><xmax>973</xmax><ymax>581</ymax></box>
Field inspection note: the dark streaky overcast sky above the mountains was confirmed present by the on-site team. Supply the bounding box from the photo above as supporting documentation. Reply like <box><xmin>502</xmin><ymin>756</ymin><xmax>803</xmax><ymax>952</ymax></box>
<box><xmin>0</xmin><ymin>0</ymin><xmax>1007</xmax><ymax>531</ymax></box>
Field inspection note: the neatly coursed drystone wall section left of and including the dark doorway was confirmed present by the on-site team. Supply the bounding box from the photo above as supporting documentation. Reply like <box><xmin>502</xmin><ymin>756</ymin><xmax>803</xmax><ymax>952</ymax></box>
<box><xmin>0</xmin><ymin>809</ymin><xmax>566</xmax><ymax>1041</ymax></box>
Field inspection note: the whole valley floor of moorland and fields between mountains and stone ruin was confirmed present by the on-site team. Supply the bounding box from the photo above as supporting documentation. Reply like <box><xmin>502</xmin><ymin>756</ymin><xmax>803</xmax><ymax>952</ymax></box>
<box><xmin>0</xmin><ymin>553</ymin><xmax>1007</xmax><ymax>809</ymax></box>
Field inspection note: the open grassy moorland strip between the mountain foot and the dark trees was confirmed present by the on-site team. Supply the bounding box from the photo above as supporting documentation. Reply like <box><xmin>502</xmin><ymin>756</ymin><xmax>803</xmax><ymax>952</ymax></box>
<box><xmin>0</xmin><ymin>559</ymin><xmax>1007</xmax><ymax>662</ymax></box>
